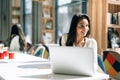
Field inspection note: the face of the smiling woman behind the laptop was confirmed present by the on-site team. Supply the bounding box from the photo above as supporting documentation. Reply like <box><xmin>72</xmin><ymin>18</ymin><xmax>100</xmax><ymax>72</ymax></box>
<box><xmin>76</xmin><ymin>19</ymin><xmax>89</xmax><ymax>37</ymax></box>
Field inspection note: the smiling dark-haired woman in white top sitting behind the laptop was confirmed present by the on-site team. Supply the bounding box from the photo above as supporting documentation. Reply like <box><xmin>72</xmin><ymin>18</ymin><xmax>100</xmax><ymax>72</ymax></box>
<box><xmin>60</xmin><ymin>14</ymin><xmax>106</xmax><ymax>73</ymax></box>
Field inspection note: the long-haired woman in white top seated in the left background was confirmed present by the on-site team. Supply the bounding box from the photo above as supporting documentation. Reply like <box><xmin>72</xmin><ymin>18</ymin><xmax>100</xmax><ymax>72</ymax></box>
<box><xmin>9</xmin><ymin>24</ymin><xmax>25</xmax><ymax>51</ymax></box>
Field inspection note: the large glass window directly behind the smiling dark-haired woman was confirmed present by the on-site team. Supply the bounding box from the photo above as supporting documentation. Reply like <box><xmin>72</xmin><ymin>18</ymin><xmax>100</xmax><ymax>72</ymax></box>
<box><xmin>56</xmin><ymin>0</ymin><xmax>88</xmax><ymax>42</ymax></box>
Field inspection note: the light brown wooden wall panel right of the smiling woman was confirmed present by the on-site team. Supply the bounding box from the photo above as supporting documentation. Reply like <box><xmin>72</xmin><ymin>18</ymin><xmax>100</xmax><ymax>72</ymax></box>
<box><xmin>89</xmin><ymin>0</ymin><xmax>107</xmax><ymax>55</ymax></box>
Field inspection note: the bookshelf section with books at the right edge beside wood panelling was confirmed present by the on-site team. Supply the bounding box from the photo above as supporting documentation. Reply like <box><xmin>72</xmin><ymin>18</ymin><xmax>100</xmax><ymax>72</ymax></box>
<box><xmin>105</xmin><ymin>0</ymin><xmax>120</xmax><ymax>48</ymax></box>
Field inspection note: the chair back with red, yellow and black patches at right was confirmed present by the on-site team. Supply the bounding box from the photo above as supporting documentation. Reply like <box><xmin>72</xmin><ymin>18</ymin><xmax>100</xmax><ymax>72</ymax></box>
<box><xmin>103</xmin><ymin>50</ymin><xmax>120</xmax><ymax>80</ymax></box>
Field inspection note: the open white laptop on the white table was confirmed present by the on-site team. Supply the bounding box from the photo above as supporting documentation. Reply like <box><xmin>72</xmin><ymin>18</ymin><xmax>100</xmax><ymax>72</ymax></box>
<box><xmin>49</xmin><ymin>46</ymin><xmax>97</xmax><ymax>76</ymax></box>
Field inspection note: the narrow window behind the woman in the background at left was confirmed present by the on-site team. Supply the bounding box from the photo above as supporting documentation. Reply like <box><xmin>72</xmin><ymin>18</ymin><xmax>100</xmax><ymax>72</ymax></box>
<box><xmin>23</xmin><ymin>0</ymin><xmax>32</xmax><ymax>41</ymax></box>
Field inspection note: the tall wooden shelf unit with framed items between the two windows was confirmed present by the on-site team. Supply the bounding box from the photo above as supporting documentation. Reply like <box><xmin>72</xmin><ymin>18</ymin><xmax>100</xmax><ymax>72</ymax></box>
<box><xmin>42</xmin><ymin>0</ymin><xmax>55</xmax><ymax>43</ymax></box>
